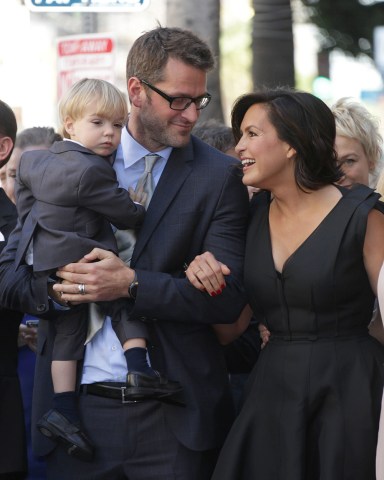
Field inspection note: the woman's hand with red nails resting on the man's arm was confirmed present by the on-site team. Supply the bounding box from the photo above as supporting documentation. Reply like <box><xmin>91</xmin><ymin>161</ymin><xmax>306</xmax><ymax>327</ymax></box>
<box><xmin>185</xmin><ymin>252</ymin><xmax>231</xmax><ymax>297</ymax></box>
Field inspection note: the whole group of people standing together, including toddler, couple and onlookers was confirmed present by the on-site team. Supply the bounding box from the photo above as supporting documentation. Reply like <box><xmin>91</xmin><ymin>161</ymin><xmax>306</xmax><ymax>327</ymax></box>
<box><xmin>0</xmin><ymin>27</ymin><xmax>384</xmax><ymax>480</ymax></box>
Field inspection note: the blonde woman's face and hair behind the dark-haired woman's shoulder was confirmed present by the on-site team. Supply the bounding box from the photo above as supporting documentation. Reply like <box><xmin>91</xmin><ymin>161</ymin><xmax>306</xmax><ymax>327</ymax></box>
<box><xmin>331</xmin><ymin>98</ymin><xmax>382</xmax><ymax>187</ymax></box>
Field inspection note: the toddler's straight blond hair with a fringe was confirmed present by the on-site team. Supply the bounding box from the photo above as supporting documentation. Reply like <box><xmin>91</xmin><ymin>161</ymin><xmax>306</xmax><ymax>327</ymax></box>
<box><xmin>59</xmin><ymin>78</ymin><xmax>128</xmax><ymax>138</ymax></box>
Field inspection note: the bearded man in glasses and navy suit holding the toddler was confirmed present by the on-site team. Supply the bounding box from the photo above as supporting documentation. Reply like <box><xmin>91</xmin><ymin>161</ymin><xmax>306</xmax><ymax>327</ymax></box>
<box><xmin>0</xmin><ymin>27</ymin><xmax>249</xmax><ymax>480</ymax></box>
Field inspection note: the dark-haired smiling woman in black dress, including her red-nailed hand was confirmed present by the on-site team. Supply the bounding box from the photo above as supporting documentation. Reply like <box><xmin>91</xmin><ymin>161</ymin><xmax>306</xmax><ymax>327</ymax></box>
<box><xmin>187</xmin><ymin>89</ymin><xmax>384</xmax><ymax>480</ymax></box>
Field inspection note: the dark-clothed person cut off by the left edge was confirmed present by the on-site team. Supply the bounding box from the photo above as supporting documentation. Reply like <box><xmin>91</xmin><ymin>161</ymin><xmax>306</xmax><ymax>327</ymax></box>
<box><xmin>0</xmin><ymin>100</ymin><xmax>27</xmax><ymax>480</ymax></box>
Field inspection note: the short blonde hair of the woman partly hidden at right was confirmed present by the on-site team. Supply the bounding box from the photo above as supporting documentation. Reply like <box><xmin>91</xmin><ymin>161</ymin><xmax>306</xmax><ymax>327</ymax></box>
<box><xmin>331</xmin><ymin>97</ymin><xmax>383</xmax><ymax>173</ymax></box>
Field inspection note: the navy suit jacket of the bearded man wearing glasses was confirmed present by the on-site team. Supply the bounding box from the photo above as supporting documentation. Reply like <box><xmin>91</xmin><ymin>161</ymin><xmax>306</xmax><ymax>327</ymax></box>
<box><xmin>0</xmin><ymin>137</ymin><xmax>248</xmax><ymax>455</ymax></box>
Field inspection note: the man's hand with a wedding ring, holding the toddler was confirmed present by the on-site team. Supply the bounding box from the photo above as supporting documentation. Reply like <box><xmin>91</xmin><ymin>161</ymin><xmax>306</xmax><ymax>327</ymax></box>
<box><xmin>53</xmin><ymin>248</ymin><xmax>135</xmax><ymax>305</ymax></box>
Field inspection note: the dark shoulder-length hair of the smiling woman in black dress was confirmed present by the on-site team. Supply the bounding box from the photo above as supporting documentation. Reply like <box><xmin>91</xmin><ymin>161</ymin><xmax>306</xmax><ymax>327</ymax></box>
<box><xmin>231</xmin><ymin>88</ymin><xmax>342</xmax><ymax>190</ymax></box>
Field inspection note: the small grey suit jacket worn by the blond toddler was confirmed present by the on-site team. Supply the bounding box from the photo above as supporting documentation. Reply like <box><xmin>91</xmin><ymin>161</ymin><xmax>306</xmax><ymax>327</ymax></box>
<box><xmin>16</xmin><ymin>141</ymin><xmax>145</xmax><ymax>271</ymax></box>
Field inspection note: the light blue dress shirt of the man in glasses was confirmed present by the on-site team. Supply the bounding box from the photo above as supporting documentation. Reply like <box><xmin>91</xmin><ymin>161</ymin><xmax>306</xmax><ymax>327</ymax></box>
<box><xmin>81</xmin><ymin>128</ymin><xmax>172</xmax><ymax>383</ymax></box>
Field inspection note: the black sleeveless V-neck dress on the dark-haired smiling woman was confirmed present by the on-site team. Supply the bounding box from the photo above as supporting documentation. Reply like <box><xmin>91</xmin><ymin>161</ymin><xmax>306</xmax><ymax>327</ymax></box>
<box><xmin>213</xmin><ymin>186</ymin><xmax>384</xmax><ymax>480</ymax></box>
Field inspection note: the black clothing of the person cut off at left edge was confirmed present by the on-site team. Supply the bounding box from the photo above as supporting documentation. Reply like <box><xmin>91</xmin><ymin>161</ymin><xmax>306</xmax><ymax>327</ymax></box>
<box><xmin>0</xmin><ymin>189</ymin><xmax>27</xmax><ymax>474</ymax></box>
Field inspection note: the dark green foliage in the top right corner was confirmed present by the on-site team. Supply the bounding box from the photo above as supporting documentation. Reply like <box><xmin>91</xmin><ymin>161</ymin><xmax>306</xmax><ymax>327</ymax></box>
<box><xmin>302</xmin><ymin>0</ymin><xmax>384</xmax><ymax>58</ymax></box>
